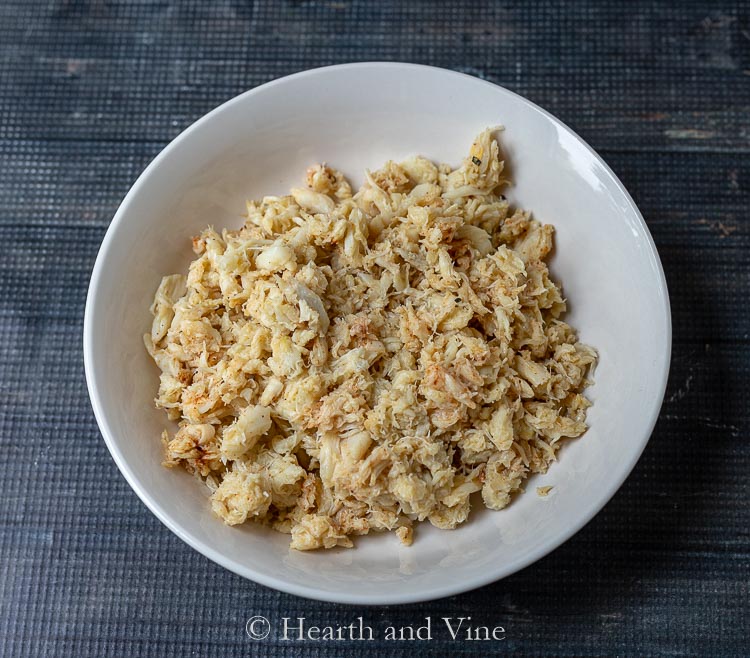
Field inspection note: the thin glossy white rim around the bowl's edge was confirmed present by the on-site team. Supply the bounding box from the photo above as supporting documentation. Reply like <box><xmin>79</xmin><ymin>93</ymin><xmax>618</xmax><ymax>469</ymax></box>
<box><xmin>83</xmin><ymin>61</ymin><xmax>672</xmax><ymax>605</ymax></box>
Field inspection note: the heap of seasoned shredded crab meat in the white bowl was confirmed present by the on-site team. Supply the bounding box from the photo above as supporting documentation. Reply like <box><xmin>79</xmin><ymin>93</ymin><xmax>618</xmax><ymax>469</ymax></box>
<box><xmin>144</xmin><ymin>130</ymin><xmax>597</xmax><ymax>550</ymax></box>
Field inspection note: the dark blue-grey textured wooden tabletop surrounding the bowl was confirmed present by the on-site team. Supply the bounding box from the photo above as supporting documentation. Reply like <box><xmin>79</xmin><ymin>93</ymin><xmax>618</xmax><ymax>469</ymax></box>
<box><xmin>0</xmin><ymin>0</ymin><xmax>750</xmax><ymax>657</ymax></box>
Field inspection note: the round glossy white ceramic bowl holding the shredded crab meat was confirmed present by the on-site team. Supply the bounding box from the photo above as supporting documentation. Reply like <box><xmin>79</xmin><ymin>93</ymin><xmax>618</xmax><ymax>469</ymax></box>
<box><xmin>84</xmin><ymin>63</ymin><xmax>671</xmax><ymax>604</ymax></box>
